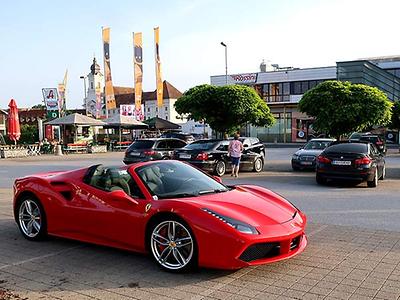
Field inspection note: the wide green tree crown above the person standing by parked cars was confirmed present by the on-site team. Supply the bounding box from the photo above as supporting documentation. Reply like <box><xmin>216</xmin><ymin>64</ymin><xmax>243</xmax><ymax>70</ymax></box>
<box><xmin>175</xmin><ymin>84</ymin><xmax>275</xmax><ymax>133</ymax></box>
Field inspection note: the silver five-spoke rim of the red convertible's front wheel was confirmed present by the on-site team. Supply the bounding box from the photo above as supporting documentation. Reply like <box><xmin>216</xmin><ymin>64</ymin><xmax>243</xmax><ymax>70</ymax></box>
<box><xmin>151</xmin><ymin>221</ymin><xmax>194</xmax><ymax>270</ymax></box>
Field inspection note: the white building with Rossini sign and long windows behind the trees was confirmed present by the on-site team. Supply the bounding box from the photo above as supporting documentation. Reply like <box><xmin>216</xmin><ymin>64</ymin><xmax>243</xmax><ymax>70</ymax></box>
<box><xmin>210</xmin><ymin>56</ymin><xmax>400</xmax><ymax>143</ymax></box>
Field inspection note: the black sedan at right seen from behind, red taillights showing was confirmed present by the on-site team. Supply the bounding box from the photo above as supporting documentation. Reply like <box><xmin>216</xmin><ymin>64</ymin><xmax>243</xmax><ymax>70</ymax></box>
<box><xmin>316</xmin><ymin>142</ymin><xmax>386</xmax><ymax>187</ymax></box>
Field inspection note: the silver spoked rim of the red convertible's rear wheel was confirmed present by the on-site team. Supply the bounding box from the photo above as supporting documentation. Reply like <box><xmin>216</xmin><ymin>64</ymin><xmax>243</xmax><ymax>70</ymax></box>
<box><xmin>18</xmin><ymin>199</ymin><xmax>42</xmax><ymax>238</ymax></box>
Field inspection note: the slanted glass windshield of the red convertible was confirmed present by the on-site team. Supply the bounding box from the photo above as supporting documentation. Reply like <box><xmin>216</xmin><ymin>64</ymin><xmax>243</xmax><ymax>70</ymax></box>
<box><xmin>136</xmin><ymin>161</ymin><xmax>229</xmax><ymax>199</ymax></box>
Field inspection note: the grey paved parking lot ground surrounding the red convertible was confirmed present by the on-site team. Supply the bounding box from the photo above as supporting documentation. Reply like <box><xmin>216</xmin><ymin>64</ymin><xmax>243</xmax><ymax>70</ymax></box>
<box><xmin>0</xmin><ymin>148</ymin><xmax>400</xmax><ymax>299</ymax></box>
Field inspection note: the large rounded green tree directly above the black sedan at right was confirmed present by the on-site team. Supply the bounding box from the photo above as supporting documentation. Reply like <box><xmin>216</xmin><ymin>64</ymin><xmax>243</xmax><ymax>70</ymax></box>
<box><xmin>299</xmin><ymin>80</ymin><xmax>392</xmax><ymax>138</ymax></box>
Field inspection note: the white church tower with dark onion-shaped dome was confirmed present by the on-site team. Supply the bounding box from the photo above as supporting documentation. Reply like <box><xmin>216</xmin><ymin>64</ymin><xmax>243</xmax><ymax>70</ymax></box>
<box><xmin>85</xmin><ymin>57</ymin><xmax>104</xmax><ymax>118</ymax></box>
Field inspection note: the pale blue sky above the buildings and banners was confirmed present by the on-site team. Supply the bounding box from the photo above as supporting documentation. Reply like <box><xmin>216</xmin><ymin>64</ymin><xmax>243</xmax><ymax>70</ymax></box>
<box><xmin>0</xmin><ymin>0</ymin><xmax>400</xmax><ymax>108</ymax></box>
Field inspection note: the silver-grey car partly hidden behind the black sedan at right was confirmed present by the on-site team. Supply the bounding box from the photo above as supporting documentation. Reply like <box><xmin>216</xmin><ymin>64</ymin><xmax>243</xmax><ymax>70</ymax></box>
<box><xmin>292</xmin><ymin>139</ymin><xmax>336</xmax><ymax>171</ymax></box>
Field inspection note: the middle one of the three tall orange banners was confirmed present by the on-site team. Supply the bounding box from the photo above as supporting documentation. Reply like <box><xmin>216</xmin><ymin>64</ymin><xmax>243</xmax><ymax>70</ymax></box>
<box><xmin>133</xmin><ymin>32</ymin><xmax>143</xmax><ymax>111</ymax></box>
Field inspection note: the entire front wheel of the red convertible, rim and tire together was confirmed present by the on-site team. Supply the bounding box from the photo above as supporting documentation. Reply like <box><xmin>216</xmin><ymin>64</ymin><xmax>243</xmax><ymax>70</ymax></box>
<box><xmin>149</xmin><ymin>217</ymin><xmax>197</xmax><ymax>272</ymax></box>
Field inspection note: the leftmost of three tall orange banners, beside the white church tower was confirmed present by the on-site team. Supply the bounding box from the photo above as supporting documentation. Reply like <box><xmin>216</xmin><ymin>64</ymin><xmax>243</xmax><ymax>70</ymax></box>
<box><xmin>103</xmin><ymin>28</ymin><xmax>116</xmax><ymax>110</ymax></box>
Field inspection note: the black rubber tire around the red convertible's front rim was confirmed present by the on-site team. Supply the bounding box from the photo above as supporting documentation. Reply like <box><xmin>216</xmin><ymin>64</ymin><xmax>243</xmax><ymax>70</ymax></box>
<box><xmin>147</xmin><ymin>216</ymin><xmax>198</xmax><ymax>273</ymax></box>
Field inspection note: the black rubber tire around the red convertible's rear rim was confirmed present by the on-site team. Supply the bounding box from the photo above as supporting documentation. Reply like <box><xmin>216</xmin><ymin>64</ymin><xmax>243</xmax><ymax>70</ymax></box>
<box><xmin>15</xmin><ymin>195</ymin><xmax>47</xmax><ymax>241</ymax></box>
